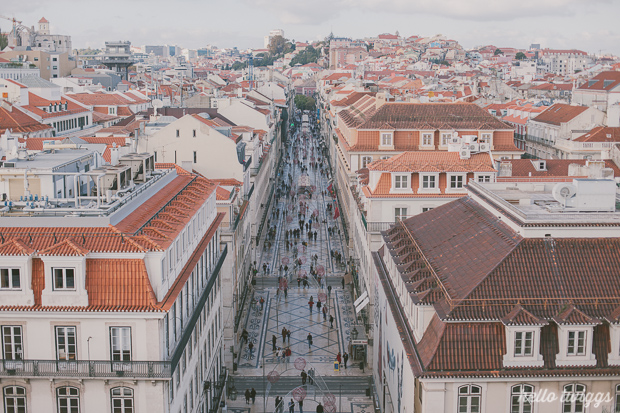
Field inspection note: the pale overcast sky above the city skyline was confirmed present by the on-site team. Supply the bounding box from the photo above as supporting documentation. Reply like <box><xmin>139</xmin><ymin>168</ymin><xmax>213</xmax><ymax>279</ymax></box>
<box><xmin>0</xmin><ymin>0</ymin><xmax>620</xmax><ymax>56</ymax></box>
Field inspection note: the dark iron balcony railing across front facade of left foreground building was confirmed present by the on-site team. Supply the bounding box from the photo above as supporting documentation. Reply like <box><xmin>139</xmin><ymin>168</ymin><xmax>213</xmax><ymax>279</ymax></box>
<box><xmin>0</xmin><ymin>360</ymin><xmax>172</xmax><ymax>379</ymax></box>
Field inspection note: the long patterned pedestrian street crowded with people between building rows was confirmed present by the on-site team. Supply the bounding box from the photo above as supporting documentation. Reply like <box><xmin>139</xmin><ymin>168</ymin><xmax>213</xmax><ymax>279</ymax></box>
<box><xmin>227</xmin><ymin>117</ymin><xmax>374</xmax><ymax>413</ymax></box>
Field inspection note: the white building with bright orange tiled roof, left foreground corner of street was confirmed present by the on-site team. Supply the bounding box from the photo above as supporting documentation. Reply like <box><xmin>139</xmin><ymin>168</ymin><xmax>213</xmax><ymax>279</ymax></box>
<box><xmin>0</xmin><ymin>149</ymin><xmax>227</xmax><ymax>413</ymax></box>
